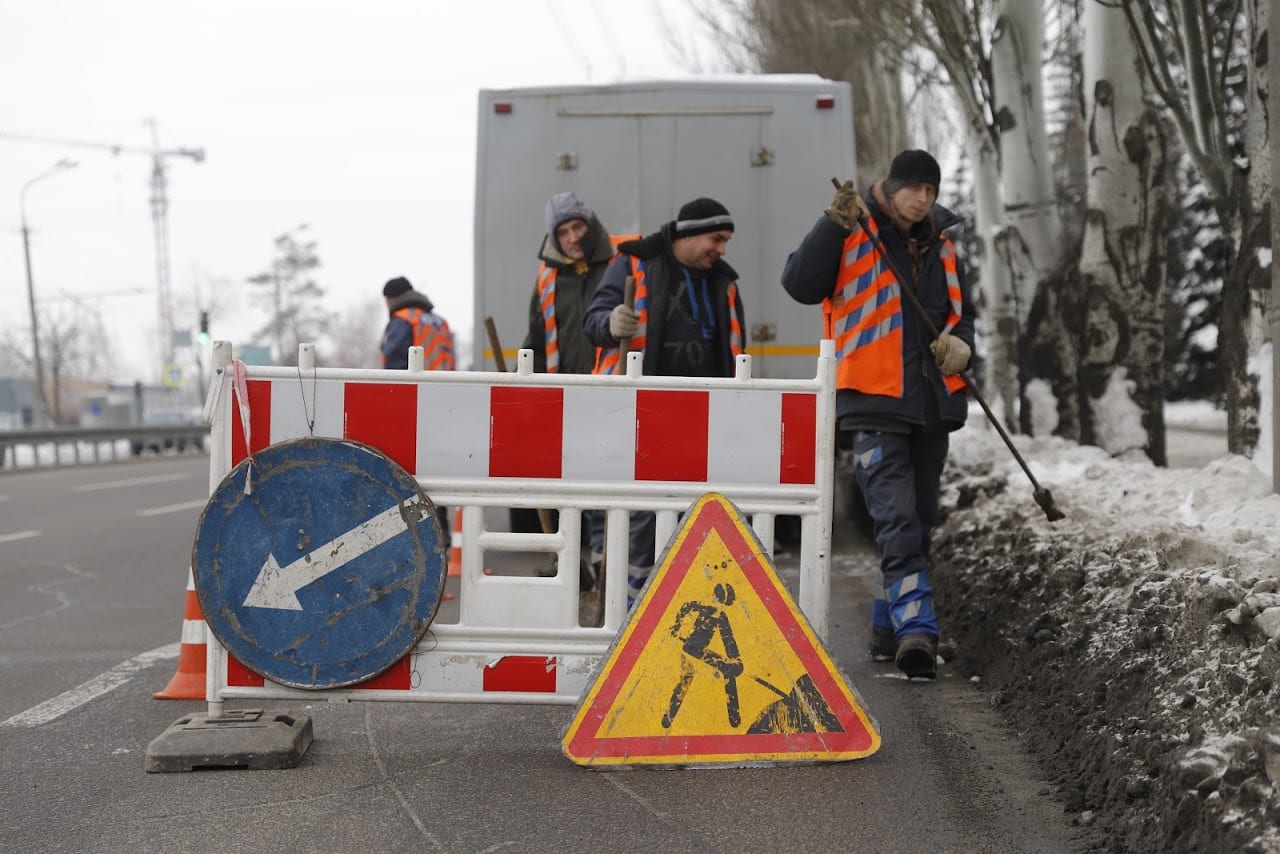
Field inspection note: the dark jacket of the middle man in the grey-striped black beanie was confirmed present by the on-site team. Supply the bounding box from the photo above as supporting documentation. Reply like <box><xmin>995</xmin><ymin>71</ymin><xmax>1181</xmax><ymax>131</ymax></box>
<box><xmin>584</xmin><ymin>223</ymin><xmax>746</xmax><ymax>376</ymax></box>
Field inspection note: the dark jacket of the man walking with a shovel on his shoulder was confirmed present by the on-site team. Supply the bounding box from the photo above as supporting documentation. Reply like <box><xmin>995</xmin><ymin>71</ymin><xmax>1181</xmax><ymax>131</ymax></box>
<box><xmin>782</xmin><ymin>191</ymin><xmax>974</xmax><ymax>433</ymax></box>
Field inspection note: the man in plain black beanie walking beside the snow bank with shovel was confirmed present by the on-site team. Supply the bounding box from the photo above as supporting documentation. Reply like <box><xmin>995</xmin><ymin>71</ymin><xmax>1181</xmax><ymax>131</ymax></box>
<box><xmin>782</xmin><ymin>150</ymin><xmax>974</xmax><ymax>679</ymax></box>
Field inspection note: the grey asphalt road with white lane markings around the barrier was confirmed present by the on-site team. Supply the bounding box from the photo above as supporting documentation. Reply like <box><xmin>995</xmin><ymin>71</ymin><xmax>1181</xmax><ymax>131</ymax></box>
<box><xmin>0</xmin><ymin>457</ymin><xmax>1100</xmax><ymax>854</ymax></box>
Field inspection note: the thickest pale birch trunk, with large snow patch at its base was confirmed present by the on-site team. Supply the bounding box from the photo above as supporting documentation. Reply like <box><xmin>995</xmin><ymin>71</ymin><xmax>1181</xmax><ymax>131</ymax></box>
<box><xmin>1079</xmin><ymin>1</ymin><xmax>1171</xmax><ymax>465</ymax></box>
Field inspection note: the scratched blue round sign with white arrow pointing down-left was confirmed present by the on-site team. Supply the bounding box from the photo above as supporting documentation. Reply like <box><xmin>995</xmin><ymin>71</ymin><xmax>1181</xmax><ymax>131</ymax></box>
<box><xmin>192</xmin><ymin>438</ymin><xmax>448</xmax><ymax>689</ymax></box>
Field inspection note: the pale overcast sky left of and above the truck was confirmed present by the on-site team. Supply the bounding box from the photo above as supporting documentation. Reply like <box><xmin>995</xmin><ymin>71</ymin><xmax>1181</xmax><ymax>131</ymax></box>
<box><xmin>0</xmin><ymin>0</ymin><xmax>713</xmax><ymax>380</ymax></box>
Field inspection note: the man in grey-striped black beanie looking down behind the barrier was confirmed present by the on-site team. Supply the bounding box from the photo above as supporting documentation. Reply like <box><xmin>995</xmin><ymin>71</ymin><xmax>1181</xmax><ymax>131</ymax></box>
<box><xmin>582</xmin><ymin>197</ymin><xmax>746</xmax><ymax>602</ymax></box>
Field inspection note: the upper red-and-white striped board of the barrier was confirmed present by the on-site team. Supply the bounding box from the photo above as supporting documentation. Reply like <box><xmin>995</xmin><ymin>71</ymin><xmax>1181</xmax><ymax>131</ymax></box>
<box><xmin>232</xmin><ymin>371</ymin><xmax>817</xmax><ymax>485</ymax></box>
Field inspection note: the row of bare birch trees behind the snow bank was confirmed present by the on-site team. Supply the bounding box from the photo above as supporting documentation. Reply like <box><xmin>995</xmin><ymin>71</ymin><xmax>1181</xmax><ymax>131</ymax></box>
<box><xmin>699</xmin><ymin>0</ymin><xmax>1271</xmax><ymax>465</ymax></box>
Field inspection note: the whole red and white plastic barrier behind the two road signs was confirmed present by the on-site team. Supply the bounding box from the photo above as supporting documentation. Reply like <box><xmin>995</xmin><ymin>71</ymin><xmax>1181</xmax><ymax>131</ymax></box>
<box><xmin>198</xmin><ymin>342</ymin><xmax>836</xmax><ymax>714</ymax></box>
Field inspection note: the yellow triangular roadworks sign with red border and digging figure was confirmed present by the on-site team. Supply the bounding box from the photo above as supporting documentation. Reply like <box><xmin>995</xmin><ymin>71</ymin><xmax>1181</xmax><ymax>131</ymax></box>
<box><xmin>561</xmin><ymin>493</ymin><xmax>881</xmax><ymax>768</ymax></box>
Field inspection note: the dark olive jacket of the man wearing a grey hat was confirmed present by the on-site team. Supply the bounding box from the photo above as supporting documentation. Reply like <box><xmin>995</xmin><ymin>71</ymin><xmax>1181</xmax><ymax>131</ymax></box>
<box><xmin>524</xmin><ymin>215</ymin><xmax>613</xmax><ymax>374</ymax></box>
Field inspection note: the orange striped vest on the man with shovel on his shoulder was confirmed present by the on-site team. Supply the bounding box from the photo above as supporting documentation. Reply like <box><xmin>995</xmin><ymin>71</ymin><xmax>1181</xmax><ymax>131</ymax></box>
<box><xmin>822</xmin><ymin>220</ymin><xmax>964</xmax><ymax>397</ymax></box>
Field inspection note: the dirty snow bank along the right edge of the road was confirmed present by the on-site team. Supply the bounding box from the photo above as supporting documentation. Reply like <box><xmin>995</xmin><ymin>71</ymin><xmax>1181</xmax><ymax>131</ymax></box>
<box><xmin>933</xmin><ymin>424</ymin><xmax>1280</xmax><ymax>853</ymax></box>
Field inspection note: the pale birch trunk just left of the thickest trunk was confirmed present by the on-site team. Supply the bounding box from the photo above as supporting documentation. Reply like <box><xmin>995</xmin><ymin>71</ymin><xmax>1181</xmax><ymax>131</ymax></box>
<box><xmin>991</xmin><ymin>0</ymin><xmax>1079</xmax><ymax>438</ymax></box>
